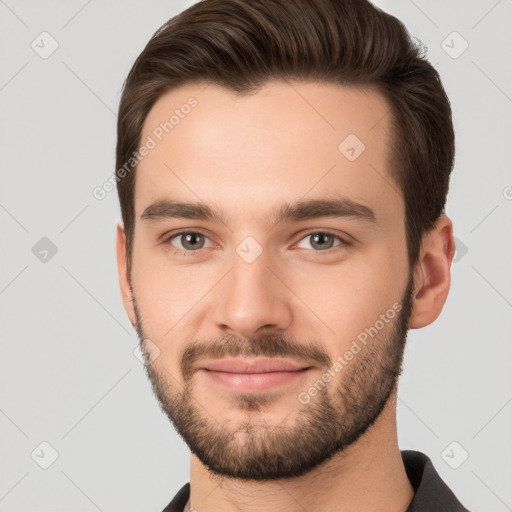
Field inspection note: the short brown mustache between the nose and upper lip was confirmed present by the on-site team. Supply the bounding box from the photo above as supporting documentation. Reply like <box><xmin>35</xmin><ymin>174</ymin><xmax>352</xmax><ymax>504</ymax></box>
<box><xmin>180</xmin><ymin>333</ymin><xmax>332</xmax><ymax>380</ymax></box>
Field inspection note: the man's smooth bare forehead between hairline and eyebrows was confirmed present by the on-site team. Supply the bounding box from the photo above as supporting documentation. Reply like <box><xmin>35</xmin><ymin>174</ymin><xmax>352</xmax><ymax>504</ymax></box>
<box><xmin>135</xmin><ymin>81</ymin><xmax>403</xmax><ymax>228</ymax></box>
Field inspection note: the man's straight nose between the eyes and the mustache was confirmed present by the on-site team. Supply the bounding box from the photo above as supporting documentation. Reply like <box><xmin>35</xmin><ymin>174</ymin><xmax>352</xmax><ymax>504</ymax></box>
<box><xmin>212</xmin><ymin>251</ymin><xmax>293</xmax><ymax>338</ymax></box>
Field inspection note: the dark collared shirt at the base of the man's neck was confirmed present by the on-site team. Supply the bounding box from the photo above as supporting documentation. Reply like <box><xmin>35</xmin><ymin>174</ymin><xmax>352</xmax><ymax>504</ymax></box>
<box><xmin>162</xmin><ymin>450</ymin><xmax>469</xmax><ymax>512</ymax></box>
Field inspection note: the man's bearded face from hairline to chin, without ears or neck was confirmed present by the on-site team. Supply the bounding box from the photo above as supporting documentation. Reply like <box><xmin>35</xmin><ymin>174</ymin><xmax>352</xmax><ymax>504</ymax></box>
<box><xmin>122</xmin><ymin>81</ymin><xmax>412</xmax><ymax>480</ymax></box>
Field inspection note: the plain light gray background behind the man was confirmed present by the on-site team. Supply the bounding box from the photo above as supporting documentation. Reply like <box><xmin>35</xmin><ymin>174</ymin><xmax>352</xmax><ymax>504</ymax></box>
<box><xmin>0</xmin><ymin>0</ymin><xmax>512</xmax><ymax>512</ymax></box>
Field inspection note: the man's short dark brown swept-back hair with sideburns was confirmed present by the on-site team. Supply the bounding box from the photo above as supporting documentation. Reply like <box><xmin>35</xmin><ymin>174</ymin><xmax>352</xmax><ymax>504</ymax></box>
<box><xmin>116</xmin><ymin>0</ymin><xmax>455</xmax><ymax>270</ymax></box>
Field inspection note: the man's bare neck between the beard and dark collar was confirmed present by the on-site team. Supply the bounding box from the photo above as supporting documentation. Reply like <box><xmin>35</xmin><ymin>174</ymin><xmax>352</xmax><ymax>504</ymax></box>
<box><xmin>189</xmin><ymin>394</ymin><xmax>414</xmax><ymax>512</ymax></box>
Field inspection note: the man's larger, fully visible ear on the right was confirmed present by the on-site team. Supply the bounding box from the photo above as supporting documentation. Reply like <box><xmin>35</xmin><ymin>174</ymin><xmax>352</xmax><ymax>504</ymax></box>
<box><xmin>409</xmin><ymin>214</ymin><xmax>455</xmax><ymax>329</ymax></box>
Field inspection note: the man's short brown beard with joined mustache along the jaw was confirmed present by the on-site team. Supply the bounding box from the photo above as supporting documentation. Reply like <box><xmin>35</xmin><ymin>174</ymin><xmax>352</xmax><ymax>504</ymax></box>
<box><xmin>132</xmin><ymin>273</ymin><xmax>413</xmax><ymax>481</ymax></box>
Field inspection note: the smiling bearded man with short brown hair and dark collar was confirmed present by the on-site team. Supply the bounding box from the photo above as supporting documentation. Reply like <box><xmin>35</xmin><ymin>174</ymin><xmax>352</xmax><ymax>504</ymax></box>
<box><xmin>116</xmin><ymin>0</ymin><xmax>466</xmax><ymax>512</ymax></box>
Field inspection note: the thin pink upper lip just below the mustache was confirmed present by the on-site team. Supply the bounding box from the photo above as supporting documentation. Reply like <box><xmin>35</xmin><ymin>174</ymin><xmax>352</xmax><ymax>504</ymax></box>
<box><xmin>200</xmin><ymin>358</ymin><xmax>309</xmax><ymax>374</ymax></box>
